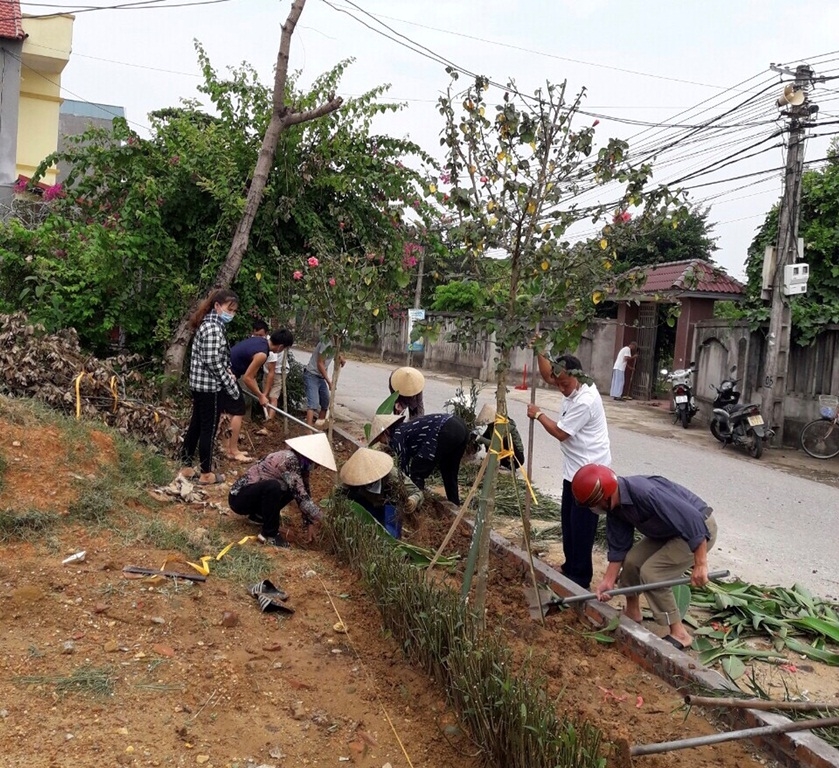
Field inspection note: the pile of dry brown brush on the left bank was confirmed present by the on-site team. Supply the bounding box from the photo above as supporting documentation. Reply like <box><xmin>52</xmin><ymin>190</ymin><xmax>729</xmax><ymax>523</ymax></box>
<box><xmin>0</xmin><ymin>312</ymin><xmax>181</xmax><ymax>454</ymax></box>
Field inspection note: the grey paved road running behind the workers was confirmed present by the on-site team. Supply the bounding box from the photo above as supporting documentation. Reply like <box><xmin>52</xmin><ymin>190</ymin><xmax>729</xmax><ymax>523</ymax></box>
<box><xmin>326</xmin><ymin>353</ymin><xmax>839</xmax><ymax>600</ymax></box>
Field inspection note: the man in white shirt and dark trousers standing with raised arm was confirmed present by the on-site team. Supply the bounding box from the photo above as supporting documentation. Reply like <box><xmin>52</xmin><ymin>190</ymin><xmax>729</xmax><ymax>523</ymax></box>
<box><xmin>527</xmin><ymin>355</ymin><xmax>612</xmax><ymax>590</ymax></box>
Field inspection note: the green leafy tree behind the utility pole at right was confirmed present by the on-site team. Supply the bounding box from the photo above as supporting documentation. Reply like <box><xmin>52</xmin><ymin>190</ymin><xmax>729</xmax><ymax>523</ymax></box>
<box><xmin>730</xmin><ymin>141</ymin><xmax>839</xmax><ymax>346</ymax></box>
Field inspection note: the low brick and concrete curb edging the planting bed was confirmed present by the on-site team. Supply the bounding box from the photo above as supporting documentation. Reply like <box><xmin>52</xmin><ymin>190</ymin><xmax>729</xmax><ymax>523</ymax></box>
<box><xmin>333</xmin><ymin>426</ymin><xmax>839</xmax><ymax>768</ymax></box>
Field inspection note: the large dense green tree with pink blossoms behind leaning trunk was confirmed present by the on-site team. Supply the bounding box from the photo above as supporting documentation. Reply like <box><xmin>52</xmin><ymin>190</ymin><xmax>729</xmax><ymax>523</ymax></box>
<box><xmin>0</xmin><ymin>46</ymin><xmax>427</xmax><ymax>362</ymax></box>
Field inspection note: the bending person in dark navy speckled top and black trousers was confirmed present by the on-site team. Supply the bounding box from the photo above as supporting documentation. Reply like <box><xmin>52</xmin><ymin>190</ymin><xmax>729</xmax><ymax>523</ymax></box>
<box><xmin>369</xmin><ymin>413</ymin><xmax>469</xmax><ymax>505</ymax></box>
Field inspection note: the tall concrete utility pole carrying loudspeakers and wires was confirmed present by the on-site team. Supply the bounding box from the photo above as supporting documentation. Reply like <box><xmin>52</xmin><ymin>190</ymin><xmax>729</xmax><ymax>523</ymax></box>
<box><xmin>761</xmin><ymin>64</ymin><xmax>818</xmax><ymax>445</ymax></box>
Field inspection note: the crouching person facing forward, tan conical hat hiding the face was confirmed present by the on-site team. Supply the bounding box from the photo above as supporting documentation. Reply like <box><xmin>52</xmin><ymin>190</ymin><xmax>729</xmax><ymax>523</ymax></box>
<box><xmin>340</xmin><ymin>448</ymin><xmax>423</xmax><ymax>538</ymax></box>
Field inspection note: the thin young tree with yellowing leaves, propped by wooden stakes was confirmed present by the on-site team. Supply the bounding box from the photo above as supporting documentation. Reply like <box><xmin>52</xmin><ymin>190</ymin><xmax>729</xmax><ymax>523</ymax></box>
<box><xmin>430</xmin><ymin>73</ymin><xmax>674</xmax><ymax>607</ymax></box>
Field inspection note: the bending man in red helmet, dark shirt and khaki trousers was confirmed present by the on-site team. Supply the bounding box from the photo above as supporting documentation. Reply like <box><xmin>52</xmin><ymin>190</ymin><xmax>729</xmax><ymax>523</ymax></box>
<box><xmin>572</xmin><ymin>464</ymin><xmax>717</xmax><ymax>650</ymax></box>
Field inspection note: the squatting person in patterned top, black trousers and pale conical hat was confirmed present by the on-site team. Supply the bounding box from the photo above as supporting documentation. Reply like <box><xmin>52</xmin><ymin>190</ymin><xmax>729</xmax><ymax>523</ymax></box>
<box><xmin>227</xmin><ymin>433</ymin><xmax>336</xmax><ymax>547</ymax></box>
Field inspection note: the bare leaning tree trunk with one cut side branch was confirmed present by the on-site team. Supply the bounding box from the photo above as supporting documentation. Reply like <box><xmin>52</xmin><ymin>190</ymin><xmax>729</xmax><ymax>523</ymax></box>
<box><xmin>159</xmin><ymin>0</ymin><xmax>343</xmax><ymax>384</ymax></box>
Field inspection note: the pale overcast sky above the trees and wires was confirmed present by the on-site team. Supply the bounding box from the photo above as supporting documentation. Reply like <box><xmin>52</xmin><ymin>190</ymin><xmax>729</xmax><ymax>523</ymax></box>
<box><xmin>22</xmin><ymin>0</ymin><xmax>839</xmax><ymax>277</ymax></box>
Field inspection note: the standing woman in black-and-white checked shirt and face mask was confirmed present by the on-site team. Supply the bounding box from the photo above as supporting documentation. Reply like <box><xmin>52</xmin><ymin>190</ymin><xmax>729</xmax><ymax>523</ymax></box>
<box><xmin>181</xmin><ymin>290</ymin><xmax>241</xmax><ymax>485</ymax></box>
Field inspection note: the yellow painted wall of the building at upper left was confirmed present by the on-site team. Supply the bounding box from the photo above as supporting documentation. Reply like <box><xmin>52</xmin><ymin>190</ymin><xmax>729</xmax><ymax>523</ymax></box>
<box><xmin>17</xmin><ymin>15</ymin><xmax>74</xmax><ymax>184</ymax></box>
